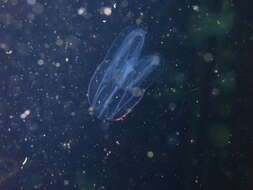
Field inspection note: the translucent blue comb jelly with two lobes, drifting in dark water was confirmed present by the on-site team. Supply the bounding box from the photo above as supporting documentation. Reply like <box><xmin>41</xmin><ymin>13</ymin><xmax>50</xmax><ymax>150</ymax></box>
<box><xmin>87</xmin><ymin>28</ymin><xmax>160</xmax><ymax>120</ymax></box>
